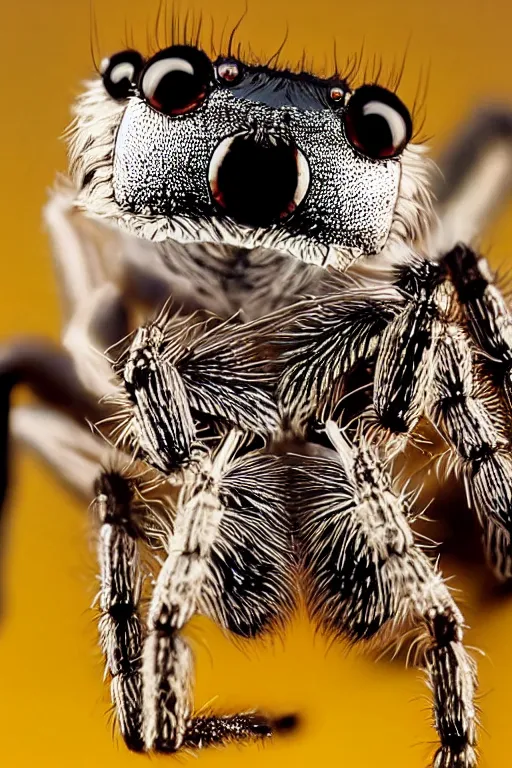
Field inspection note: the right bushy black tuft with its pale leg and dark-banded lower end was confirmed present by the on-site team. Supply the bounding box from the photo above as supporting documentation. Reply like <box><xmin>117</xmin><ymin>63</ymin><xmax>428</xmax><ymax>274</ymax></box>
<box><xmin>298</xmin><ymin>422</ymin><xmax>476</xmax><ymax>768</ymax></box>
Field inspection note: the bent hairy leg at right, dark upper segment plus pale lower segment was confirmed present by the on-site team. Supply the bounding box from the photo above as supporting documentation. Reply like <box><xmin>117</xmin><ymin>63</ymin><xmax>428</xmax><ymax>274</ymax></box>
<box><xmin>368</xmin><ymin>249</ymin><xmax>512</xmax><ymax>578</ymax></box>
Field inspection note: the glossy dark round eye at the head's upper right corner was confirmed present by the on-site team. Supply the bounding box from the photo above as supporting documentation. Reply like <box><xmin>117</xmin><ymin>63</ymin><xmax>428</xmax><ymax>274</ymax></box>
<box><xmin>344</xmin><ymin>85</ymin><xmax>412</xmax><ymax>160</ymax></box>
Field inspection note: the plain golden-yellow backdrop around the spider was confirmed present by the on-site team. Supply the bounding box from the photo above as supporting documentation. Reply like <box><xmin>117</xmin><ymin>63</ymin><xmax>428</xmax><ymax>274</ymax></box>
<box><xmin>0</xmin><ymin>0</ymin><xmax>512</xmax><ymax>768</ymax></box>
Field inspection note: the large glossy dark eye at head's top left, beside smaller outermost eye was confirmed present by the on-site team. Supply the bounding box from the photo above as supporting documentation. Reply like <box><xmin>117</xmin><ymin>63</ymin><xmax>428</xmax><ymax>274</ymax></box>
<box><xmin>140</xmin><ymin>45</ymin><xmax>213</xmax><ymax>115</ymax></box>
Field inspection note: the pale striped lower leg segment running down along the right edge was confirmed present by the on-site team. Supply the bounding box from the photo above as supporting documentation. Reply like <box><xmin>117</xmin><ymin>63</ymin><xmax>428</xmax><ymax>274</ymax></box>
<box><xmin>428</xmin><ymin>325</ymin><xmax>512</xmax><ymax>579</ymax></box>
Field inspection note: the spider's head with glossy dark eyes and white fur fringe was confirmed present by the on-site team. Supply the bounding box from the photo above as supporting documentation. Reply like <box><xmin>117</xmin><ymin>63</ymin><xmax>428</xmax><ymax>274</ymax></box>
<box><xmin>71</xmin><ymin>45</ymin><xmax>429</xmax><ymax>265</ymax></box>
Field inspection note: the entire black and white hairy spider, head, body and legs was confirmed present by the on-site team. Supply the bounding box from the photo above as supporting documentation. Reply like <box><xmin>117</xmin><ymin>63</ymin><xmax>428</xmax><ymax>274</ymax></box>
<box><xmin>0</xmin><ymin>28</ymin><xmax>512</xmax><ymax>768</ymax></box>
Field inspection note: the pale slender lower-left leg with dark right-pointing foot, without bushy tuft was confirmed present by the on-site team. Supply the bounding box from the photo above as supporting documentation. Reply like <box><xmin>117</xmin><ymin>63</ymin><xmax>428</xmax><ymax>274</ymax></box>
<box><xmin>143</xmin><ymin>435</ymin><xmax>258</xmax><ymax>752</ymax></box>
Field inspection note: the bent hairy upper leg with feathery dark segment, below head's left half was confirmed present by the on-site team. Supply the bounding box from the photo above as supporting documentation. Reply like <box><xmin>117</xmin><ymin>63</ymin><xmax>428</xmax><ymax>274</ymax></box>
<box><xmin>112</xmin><ymin>308</ymin><xmax>289</xmax><ymax>475</ymax></box>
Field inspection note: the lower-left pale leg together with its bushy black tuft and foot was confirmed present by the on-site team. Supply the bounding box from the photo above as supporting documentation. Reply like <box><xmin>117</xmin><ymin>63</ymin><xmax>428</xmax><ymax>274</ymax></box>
<box><xmin>143</xmin><ymin>432</ymin><xmax>293</xmax><ymax>752</ymax></box>
